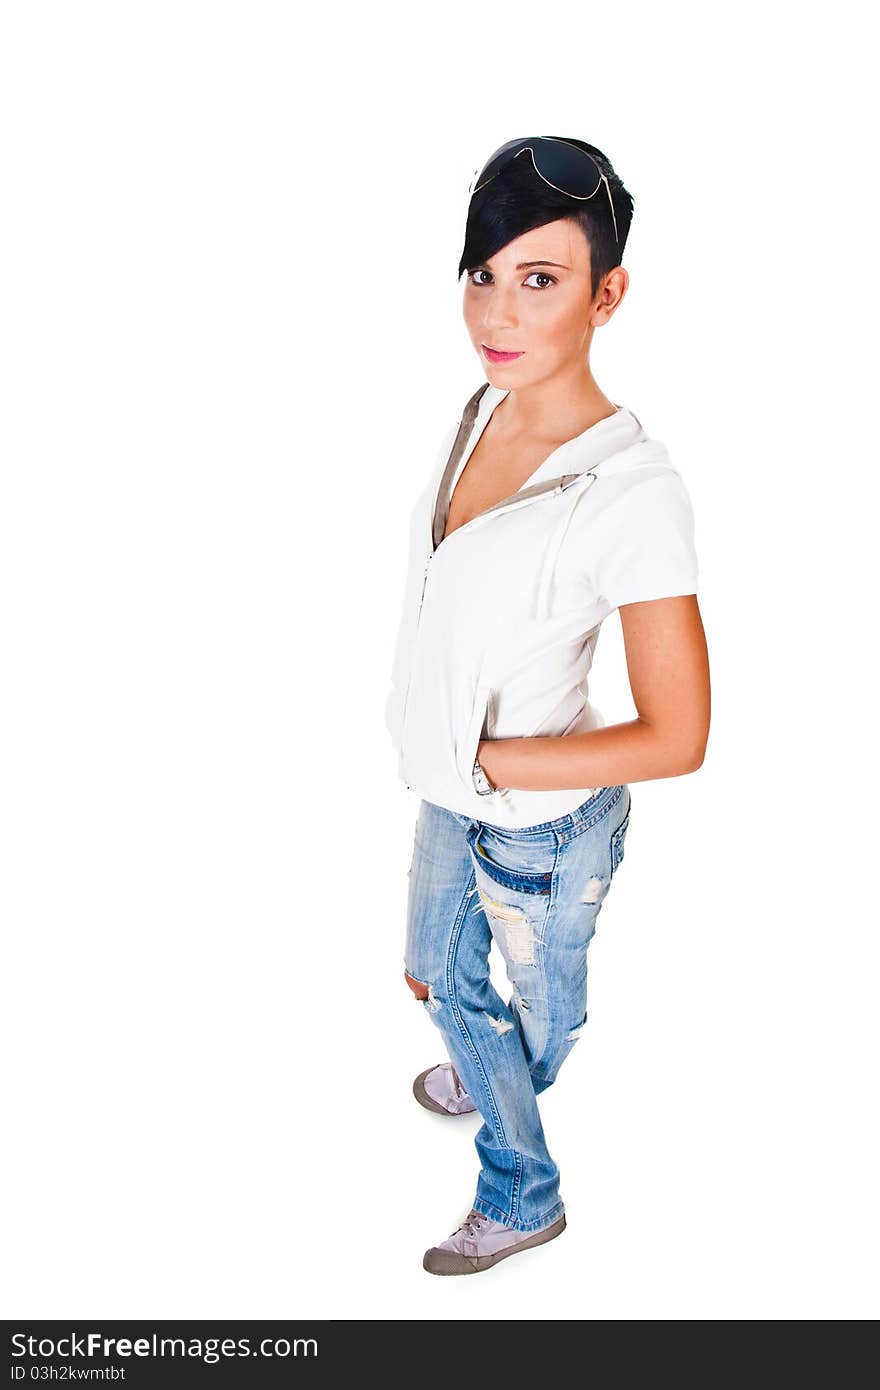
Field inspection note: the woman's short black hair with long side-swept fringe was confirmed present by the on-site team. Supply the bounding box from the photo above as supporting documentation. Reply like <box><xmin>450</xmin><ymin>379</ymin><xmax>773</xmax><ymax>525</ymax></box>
<box><xmin>459</xmin><ymin>135</ymin><xmax>633</xmax><ymax>297</ymax></box>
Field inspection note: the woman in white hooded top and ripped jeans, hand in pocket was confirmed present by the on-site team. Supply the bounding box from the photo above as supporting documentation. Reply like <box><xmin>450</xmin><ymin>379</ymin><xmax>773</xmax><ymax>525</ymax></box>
<box><xmin>386</xmin><ymin>136</ymin><xmax>710</xmax><ymax>1275</ymax></box>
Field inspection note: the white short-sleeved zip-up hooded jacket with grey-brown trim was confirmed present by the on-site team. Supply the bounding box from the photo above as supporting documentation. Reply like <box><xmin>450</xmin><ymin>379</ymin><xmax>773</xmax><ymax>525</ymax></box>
<box><xmin>385</xmin><ymin>382</ymin><xmax>698</xmax><ymax>828</ymax></box>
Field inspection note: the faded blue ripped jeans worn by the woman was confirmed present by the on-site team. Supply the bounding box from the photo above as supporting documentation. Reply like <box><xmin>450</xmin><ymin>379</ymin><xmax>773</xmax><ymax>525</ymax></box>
<box><xmin>405</xmin><ymin>785</ymin><xmax>630</xmax><ymax>1232</ymax></box>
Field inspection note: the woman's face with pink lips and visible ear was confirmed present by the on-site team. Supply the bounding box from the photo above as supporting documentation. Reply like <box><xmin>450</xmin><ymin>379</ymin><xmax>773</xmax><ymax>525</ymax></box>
<box><xmin>464</xmin><ymin>218</ymin><xmax>628</xmax><ymax>389</ymax></box>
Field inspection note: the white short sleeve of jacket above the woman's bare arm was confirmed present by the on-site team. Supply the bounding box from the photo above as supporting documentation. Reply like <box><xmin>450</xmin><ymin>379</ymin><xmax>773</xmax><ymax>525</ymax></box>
<box><xmin>592</xmin><ymin>468</ymin><xmax>698</xmax><ymax>609</ymax></box>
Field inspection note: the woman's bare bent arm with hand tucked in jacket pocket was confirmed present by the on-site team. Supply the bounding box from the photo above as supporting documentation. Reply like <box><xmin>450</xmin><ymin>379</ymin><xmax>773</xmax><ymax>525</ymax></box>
<box><xmin>480</xmin><ymin>594</ymin><xmax>710</xmax><ymax>791</ymax></box>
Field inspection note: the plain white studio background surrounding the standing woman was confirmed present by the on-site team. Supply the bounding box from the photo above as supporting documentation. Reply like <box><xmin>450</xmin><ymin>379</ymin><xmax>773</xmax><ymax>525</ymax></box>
<box><xmin>0</xmin><ymin>0</ymin><xmax>880</xmax><ymax>1323</ymax></box>
